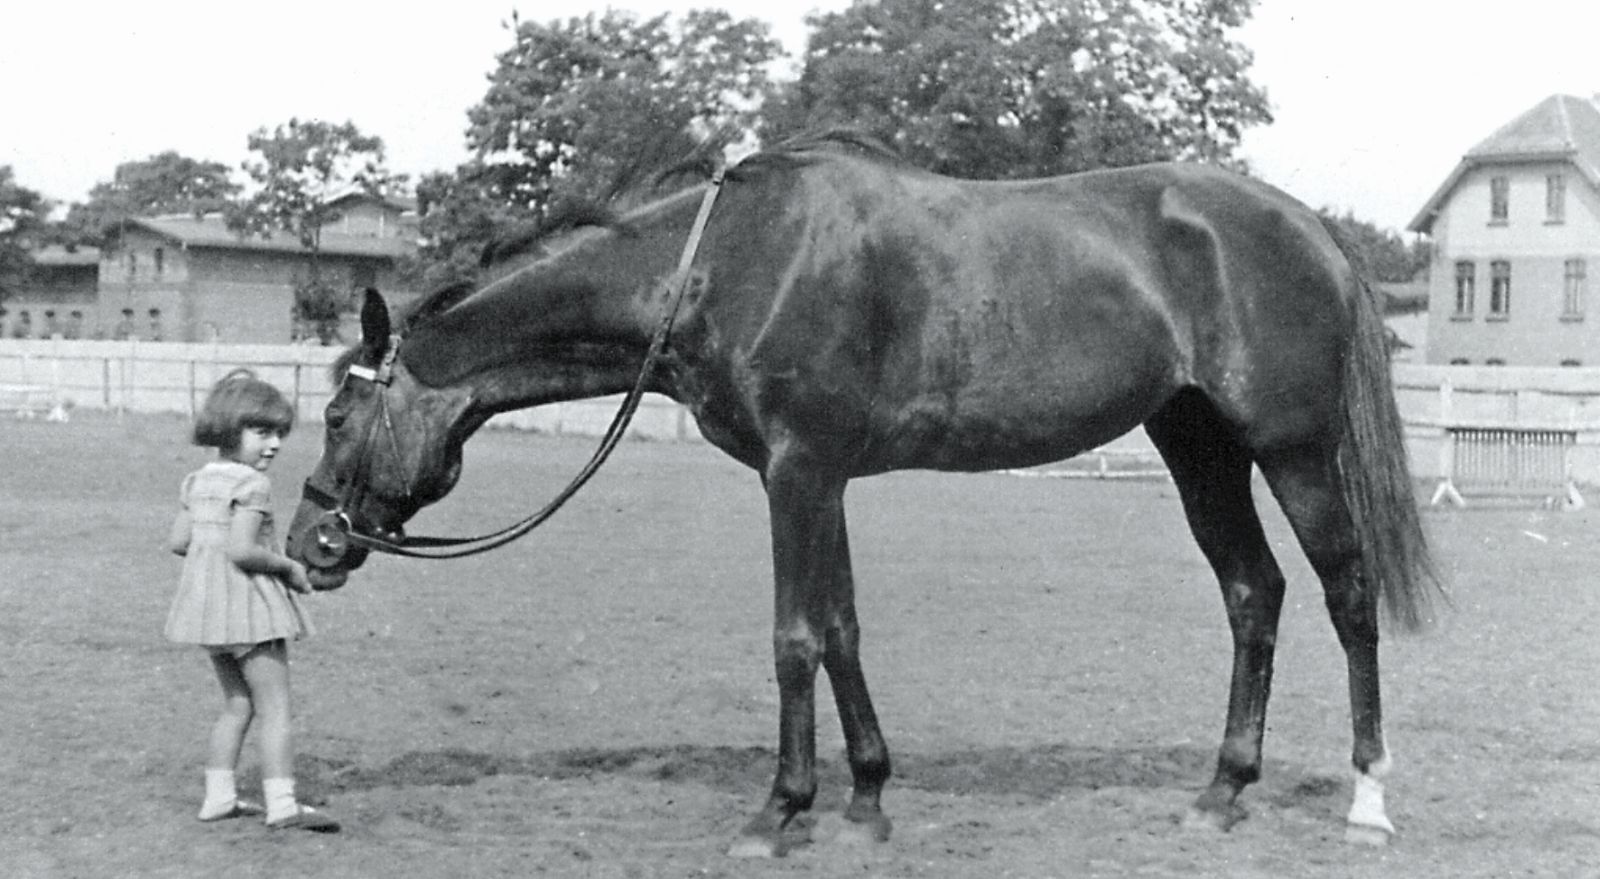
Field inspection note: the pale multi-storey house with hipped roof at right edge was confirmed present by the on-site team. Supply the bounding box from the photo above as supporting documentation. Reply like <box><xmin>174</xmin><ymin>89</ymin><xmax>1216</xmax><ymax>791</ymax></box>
<box><xmin>1408</xmin><ymin>94</ymin><xmax>1600</xmax><ymax>367</ymax></box>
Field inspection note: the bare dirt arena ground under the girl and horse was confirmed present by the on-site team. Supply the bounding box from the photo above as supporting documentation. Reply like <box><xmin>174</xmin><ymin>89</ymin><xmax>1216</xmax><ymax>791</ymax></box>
<box><xmin>0</xmin><ymin>413</ymin><xmax>1600</xmax><ymax>879</ymax></box>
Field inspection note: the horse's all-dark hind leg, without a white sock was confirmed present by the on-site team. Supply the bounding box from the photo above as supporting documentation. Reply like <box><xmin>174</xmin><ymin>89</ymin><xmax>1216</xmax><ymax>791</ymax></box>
<box><xmin>1146</xmin><ymin>394</ymin><xmax>1283</xmax><ymax>829</ymax></box>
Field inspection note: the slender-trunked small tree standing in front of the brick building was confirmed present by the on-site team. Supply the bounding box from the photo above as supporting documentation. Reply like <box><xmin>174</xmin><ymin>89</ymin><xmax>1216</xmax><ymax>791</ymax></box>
<box><xmin>227</xmin><ymin>118</ymin><xmax>405</xmax><ymax>344</ymax></box>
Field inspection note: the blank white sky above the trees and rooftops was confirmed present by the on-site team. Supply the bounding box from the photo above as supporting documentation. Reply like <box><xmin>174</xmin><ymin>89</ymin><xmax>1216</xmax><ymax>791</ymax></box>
<box><xmin>0</xmin><ymin>0</ymin><xmax>1600</xmax><ymax>231</ymax></box>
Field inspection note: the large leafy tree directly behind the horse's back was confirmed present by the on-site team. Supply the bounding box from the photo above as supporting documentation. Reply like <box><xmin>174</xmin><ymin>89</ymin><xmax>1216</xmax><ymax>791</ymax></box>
<box><xmin>762</xmin><ymin>0</ymin><xmax>1272</xmax><ymax>179</ymax></box>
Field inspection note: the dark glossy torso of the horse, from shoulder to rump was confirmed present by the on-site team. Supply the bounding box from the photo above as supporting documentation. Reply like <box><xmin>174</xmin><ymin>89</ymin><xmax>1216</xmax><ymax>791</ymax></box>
<box><xmin>707</xmin><ymin>160</ymin><xmax>1347</xmax><ymax>471</ymax></box>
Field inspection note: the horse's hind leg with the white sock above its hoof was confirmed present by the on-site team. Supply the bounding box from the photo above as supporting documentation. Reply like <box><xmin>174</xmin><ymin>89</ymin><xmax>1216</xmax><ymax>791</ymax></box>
<box><xmin>1261</xmin><ymin>445</ymin><xmax>1395</xmax><ymax>844</ymax></box>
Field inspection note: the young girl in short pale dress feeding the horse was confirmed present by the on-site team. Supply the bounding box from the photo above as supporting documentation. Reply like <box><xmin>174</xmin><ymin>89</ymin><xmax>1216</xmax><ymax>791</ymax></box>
<box><xmin>166</xmin><ymin>370</ymin><xmax>339</xmax><ymax>833</ymax></box>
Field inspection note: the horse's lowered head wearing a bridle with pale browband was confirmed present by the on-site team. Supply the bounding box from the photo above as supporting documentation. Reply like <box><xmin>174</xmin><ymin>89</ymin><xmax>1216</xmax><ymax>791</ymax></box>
<box><xmin>286</xmin><ymin>290</ymin><xmax>470</xmax><ymax>589</ymax></box>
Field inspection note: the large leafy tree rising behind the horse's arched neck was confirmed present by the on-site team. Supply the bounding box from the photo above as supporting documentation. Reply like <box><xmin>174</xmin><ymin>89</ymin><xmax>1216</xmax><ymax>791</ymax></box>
<box><xmin>406</xmin><ymin>10</ymin><xmax>779</xmax><ymax>280</ymax></box>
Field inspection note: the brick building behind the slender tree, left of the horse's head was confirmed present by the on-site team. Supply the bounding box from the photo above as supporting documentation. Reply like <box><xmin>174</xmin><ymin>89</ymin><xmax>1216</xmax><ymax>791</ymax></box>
<box><xmin>94</xmin><ymin>194</ymin><xmax>418</xmax><ymax>344</ymax></box>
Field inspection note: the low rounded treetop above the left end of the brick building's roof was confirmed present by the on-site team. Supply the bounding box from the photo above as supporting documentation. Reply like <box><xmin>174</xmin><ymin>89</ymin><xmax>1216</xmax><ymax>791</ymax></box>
<box><xmin>64</xmin><ymin>151</ymin><xmax>240</xmax><ymax>245</ymax></box>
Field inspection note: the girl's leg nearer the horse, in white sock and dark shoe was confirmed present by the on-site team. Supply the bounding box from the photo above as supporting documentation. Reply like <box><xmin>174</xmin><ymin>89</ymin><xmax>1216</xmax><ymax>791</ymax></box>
<box><xmin>242</xmin><ymin>640</ymin><xmax>339</xmax><ymax>833</ymax></box>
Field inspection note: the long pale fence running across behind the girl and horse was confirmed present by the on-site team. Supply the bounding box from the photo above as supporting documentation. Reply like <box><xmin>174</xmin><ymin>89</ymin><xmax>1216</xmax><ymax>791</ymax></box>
<box><xmin>9</xmin><ymin>339</ymin><xmax>1600</xmax><ymax>484</ymax></box>
